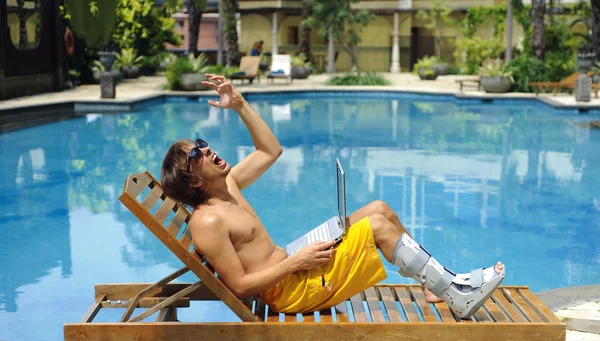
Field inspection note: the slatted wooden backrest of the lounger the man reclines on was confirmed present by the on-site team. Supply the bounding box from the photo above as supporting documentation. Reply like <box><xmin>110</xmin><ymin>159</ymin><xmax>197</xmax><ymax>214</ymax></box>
<box><xmin>119</xmin><ymin>172</ymin><xmax>263</xmax><ymax>322</ymax></box>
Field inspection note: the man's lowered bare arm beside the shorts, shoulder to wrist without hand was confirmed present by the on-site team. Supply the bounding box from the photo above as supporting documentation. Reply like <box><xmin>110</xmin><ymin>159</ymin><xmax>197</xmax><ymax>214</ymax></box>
<box><xmin>190</xmin><ymin>215</ymin><xmax>298</xmax><ymax>298</ymax></box>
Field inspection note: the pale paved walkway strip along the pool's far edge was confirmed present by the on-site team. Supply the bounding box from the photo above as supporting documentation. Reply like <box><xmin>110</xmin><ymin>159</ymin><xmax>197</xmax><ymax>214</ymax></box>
<box><xmin>0</xmin><ymin>73</ymin><xmax>600</xmax><ymax>110</ymax></box>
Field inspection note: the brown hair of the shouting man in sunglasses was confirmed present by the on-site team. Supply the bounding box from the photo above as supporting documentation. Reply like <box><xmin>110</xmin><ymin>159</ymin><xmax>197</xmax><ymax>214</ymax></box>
<box><xmin>160</xmin><ymin>140</ymin><xmax>209</xmax><ymax>208</ymax></box>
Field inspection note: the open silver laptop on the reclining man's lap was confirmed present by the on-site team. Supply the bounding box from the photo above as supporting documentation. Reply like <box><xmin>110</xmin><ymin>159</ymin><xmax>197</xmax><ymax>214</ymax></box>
<box><xmin>285</xmin><ymin>158</ymin><xmax>348</xmax><ymax>256</ymax></box>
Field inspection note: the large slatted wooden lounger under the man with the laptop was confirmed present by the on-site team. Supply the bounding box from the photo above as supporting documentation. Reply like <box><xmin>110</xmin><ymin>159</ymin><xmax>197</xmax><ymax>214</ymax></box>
<box><xmin>64</xmin><ymin>172</ymin><xmax>566</xmax><ymax>341</ymax></box>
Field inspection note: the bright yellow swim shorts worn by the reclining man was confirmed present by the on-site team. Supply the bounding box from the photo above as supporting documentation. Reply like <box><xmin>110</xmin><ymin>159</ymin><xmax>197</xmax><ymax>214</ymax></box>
<box><xmin>260</xmin><ymin>217</ymin><xmax>387</xmax><ymax>313</ymax></box>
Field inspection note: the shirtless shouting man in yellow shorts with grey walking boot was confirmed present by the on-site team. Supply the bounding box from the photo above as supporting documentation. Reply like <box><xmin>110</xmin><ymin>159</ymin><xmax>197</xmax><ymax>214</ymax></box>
<box><xmin>161</xmin><ymin>74</ymin><xmax>505</xmax><ymax>318</ymax></box>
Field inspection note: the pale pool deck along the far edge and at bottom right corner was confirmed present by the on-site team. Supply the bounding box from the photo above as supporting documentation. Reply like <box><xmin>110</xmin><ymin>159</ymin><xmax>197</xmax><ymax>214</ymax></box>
<box><xmin>0</xmin><ymin>73</ymin><xmax>600</xmax><ymax>341</ymax></box>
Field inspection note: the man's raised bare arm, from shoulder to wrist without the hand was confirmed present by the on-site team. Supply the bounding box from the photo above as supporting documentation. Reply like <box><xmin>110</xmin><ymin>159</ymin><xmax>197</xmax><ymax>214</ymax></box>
<box><xmin>231</xmin><ymin>100</ymin><xmax>283</xmax><ymax>190</ymax></box>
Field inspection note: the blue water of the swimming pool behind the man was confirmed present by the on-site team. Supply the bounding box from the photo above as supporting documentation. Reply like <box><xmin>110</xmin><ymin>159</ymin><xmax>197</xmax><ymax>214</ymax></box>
<box><xmin>0</xmin><ymin>93</ymin><xmax>600</xmax><ymax>341</ymax></box>
